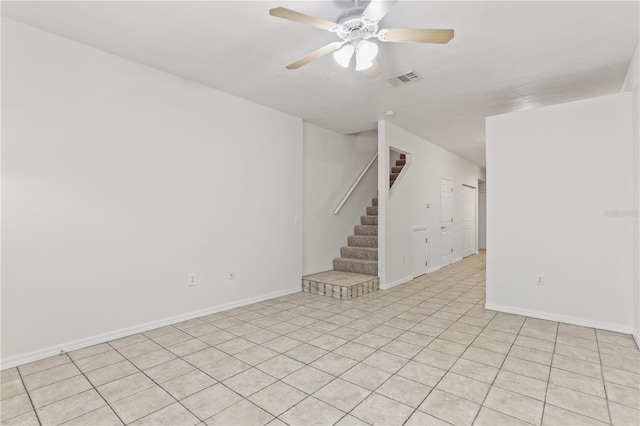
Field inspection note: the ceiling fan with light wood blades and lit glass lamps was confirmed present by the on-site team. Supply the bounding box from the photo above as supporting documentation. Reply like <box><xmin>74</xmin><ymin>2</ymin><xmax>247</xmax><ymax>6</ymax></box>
<box><xmin>269</xmin><ymin>0</ymin><xmax>453</xmax><ymax>76</ymax></box>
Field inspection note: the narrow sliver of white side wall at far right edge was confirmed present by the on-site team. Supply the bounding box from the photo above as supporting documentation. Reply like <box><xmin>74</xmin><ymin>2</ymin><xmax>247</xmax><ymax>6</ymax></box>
<box><xmin>622</xmin><ymin>43</ymin><xmax>640</xmax><ymax>347</ymax></box>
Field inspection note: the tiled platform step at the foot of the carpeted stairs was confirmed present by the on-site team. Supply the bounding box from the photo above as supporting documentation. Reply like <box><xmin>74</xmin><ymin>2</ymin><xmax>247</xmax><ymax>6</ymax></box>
<box><xmin>302</xmin><ymin>271</ymin><xmax>380</xmax><ymax>300</ymax></box>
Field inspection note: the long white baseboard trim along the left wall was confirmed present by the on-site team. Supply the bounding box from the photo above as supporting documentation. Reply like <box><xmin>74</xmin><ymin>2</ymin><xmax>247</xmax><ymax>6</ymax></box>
<box><xmin>0</xmin><ymin>287</ymin><xmax>301</xmax><ymax>370</ymax></box>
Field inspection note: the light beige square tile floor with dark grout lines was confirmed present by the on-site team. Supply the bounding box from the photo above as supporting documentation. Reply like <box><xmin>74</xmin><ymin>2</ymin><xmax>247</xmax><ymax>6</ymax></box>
<box><xmin>0</xmin><ymin>253</ymin><xmax>640</xmax><ymax>426</ymax></box>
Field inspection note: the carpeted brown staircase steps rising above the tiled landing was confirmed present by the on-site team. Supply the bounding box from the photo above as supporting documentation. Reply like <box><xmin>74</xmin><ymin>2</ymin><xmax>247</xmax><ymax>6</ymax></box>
<box><xmin>333</xmin><ymin>197</ymin><xmax>378</xmax><ymax>276</ymax></box>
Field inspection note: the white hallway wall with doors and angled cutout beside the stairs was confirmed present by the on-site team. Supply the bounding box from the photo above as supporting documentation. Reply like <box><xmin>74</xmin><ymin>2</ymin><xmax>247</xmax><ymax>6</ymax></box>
<box><xmin>378</xmin><ymin>121</ymin><xmax>484</xmax><ymax>288</ymax></box>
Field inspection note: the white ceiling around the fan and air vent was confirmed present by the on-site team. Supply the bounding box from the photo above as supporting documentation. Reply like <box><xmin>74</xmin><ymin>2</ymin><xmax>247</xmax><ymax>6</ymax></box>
<box><xmin>2</xmin><ymin>0</ymin><xmax>639</xmax><ymax>165</ymax></box>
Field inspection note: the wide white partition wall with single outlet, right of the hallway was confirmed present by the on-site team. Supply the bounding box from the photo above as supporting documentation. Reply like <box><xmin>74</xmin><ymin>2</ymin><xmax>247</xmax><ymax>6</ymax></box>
<box><xmin>487</xmin><ymin>93</ymin><xmax>633</xmax><ymax>332</ymax></box>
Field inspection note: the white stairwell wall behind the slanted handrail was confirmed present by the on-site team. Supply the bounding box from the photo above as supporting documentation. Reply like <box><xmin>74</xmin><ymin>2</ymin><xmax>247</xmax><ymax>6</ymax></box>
<box><xmin>302</xmin><ymin>123</ymin><xmax>378</xmax><ymax>275</ymax></box>
